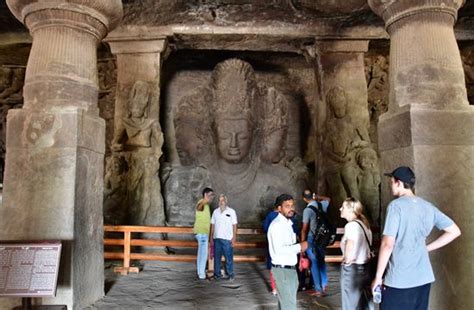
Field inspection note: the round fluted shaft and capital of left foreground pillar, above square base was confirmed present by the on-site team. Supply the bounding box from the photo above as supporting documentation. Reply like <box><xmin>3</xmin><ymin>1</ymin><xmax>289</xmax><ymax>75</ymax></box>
<box><xmin>7</xmin><ymin>0</ymin><xmax>123</xmax><ymax>114</ymax></box>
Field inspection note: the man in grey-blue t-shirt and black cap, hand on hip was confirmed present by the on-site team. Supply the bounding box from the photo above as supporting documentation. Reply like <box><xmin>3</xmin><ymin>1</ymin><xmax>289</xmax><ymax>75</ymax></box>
<box><xmin>372</xmin><ymin>167</ymin><xmax>461</xmax><ymax>310</ymax></box>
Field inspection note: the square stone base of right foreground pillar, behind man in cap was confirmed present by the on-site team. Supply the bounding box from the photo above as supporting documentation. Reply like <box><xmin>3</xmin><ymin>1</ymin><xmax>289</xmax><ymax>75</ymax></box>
<box><xmin>379</xmin><ymin>106</ymin><xmax>474</xmax><ymax>309</ymax></box>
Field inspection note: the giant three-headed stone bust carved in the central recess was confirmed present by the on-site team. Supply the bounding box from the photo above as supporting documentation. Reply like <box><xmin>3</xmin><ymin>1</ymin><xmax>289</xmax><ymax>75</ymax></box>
<box><xmin>162</xmin><ymin>58</ymin><xmax>306</xmax><ymax>226</ymax></box>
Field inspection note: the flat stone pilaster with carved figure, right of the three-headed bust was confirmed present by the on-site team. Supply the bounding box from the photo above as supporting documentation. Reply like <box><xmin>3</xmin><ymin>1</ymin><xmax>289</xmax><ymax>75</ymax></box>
<box><xmin>316</xmin><ymin>40</ymin><xmax>378</xmax><ymax>220</ymax></box>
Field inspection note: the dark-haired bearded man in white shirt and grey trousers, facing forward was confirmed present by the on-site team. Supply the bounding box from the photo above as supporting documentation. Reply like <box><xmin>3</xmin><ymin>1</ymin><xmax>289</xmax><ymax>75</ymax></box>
<box><xmin>267</xmin><ymin>194</ymin><xmax>308</xmax><ymax>310</ymax></box>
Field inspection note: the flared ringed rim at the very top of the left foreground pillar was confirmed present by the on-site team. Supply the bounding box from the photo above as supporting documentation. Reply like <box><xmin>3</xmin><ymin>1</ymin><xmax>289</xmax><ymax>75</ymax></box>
<box><xmin>7</xmin><ymin>0</ymin><xmax>123</xmax><ymax>41</ymax></box>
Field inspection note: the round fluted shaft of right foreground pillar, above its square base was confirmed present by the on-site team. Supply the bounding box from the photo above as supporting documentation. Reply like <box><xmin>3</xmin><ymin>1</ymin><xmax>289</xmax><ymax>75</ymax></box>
<box><xmin>383</xmin><ymin>0</ymin><xmax>467</xmax><ymax>109</ymax></box>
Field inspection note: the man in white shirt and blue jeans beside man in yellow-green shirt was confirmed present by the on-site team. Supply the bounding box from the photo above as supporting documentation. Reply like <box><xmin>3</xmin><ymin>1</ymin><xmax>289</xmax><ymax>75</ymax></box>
<box><xmin>211</xmin><ymin>194</ymin><xmax>237</xmax><ymax>281</ymax></box>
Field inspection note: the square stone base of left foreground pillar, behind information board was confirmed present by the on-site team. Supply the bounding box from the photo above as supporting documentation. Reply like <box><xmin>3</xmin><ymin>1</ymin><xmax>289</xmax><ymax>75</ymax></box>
<box><xmin>0</xmin><ymin>109</ymin><xmax>105</xmax><ymax>309</ymax></box>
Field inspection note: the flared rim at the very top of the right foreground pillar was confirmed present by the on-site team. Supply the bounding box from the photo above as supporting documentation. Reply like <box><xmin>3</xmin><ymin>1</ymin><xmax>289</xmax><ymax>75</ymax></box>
<box><xmin>368</xmin><ymin>0</ymin><xmax>465</xmax><ymax>30</ymax></box>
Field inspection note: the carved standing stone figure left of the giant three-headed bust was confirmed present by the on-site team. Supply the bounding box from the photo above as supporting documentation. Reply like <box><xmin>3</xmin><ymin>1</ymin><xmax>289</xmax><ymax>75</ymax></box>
<box><xmin>104</xmin><ymin>81</ymin><xmax>165</xmax><ymax>225</ymax></box>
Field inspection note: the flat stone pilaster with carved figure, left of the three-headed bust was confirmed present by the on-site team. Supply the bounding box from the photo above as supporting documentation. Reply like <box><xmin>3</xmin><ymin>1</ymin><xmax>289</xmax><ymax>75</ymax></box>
<box><xmin>107</xmin><ymin>34</ymin><xmax>168</xmax><ymax>225</ymax></box>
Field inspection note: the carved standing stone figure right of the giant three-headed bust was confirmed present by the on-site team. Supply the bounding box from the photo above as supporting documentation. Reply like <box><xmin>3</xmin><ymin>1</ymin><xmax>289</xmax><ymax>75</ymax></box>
<box><xmin>323</xmin><ymin>86</ymin><xmax>380</xmax><ymax>221</ymax></box>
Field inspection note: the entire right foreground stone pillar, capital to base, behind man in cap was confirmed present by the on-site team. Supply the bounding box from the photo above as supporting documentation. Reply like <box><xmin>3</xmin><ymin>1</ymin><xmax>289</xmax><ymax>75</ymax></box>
<box><xmin>369</xmin><ymin>0</ymin><xmax>474</xmax><ymax>309</ymax></box>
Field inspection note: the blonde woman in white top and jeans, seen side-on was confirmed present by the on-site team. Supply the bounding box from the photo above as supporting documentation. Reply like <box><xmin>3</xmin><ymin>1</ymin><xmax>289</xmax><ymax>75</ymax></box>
<box><xmin>339</xmin><ymin>198</ymin><xmax>374</xmax><ymax>310</ymax></box>
